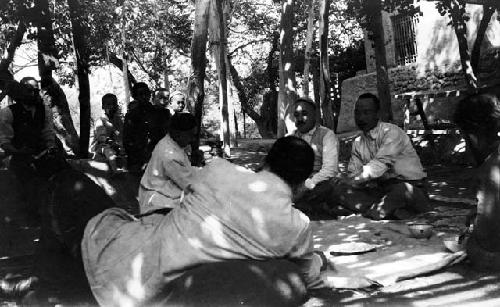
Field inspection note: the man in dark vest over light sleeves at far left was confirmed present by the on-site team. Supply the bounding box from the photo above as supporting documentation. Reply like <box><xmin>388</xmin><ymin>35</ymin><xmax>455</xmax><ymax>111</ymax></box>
<box><xmin>0</xmin><ymin>80</ymin><xmax>56</xmax><ymax>225</ymax></box>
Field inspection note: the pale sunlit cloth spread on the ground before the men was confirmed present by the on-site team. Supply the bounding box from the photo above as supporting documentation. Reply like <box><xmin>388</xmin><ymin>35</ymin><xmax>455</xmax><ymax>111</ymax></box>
<box><xmin>311</xmin><ymin>215</ymin><xmax>465</xmax><ymax>288</ymax></box>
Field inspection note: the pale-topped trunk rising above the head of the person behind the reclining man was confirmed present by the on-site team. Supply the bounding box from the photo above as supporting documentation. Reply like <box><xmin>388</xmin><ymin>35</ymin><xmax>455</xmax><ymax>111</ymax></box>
<box><xmin>189</xmin><ymin>0</ymin><xmax>210</xmax><ymax>150</ymax></box>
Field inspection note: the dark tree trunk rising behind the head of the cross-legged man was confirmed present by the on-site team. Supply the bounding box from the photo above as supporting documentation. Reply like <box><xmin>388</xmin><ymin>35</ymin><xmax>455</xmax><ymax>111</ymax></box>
<box><xmin>366</xmin><ymin>0</ymin><xmax>392</xmax><ymax>121</ymax></box>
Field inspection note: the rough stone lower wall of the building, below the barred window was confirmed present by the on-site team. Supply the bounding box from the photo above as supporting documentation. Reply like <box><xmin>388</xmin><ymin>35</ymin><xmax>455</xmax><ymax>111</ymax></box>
<box><xmin>337</xmin><ymin>48</ymin><xmax>500</xmax><ymax>133</ymax></box>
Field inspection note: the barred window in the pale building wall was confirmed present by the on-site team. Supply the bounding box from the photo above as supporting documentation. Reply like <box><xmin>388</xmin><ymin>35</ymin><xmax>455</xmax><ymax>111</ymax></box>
<box><xmin>391</xmin><ymin>15</ymin><xmax>418</xmax><ymax>65</ymax></box>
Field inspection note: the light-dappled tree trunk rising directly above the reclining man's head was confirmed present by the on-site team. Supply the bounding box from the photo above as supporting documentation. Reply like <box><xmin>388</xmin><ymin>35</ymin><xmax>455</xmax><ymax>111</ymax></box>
<box><xmin>277</xmin><ymin>0</ymin><xmax>296</xmax><ymax>137</ymax></box>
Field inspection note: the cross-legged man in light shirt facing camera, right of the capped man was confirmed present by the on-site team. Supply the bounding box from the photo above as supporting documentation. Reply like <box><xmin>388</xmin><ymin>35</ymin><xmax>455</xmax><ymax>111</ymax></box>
<box><xmin>335</xmin><ymin>94</ymin><xmax>429</xmax><ymax>219</ymax></box>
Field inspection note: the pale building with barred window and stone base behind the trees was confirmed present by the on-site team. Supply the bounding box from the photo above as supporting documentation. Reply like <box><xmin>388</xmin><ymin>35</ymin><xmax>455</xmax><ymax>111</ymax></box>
<box><xmin>337</xmin><ymin>1</ymin><xmax>500</xmax><ymax>132</ymax></box>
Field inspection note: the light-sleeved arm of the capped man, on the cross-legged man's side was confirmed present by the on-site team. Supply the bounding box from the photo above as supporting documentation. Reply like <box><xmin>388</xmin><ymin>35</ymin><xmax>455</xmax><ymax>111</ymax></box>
<box><xmin>306</xmin><ymin>131</ymin><xmax>339</xmax><ymax>187</ymax></box>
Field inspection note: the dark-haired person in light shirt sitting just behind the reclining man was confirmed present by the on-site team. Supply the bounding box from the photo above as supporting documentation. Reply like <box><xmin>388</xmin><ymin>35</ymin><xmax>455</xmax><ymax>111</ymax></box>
<box><xmin>139</xmin><ymin>113</ymin><xmax>196</xmax><ymax>213</ymax></box>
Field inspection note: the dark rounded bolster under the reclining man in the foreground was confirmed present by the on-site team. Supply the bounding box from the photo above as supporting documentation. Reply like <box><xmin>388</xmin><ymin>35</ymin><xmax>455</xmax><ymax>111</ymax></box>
<box><xmin>150</xmin><ymin>259</ymin><xmax>307</xmax><ymax>306</ymax></box>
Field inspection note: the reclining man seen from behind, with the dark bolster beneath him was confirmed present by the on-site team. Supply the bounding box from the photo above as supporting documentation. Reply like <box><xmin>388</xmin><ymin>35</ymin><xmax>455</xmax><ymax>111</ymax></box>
<box><xmin>82</xmin><ymin>136</ymin><xmax>325</xmax><ymax>306</ymax></box>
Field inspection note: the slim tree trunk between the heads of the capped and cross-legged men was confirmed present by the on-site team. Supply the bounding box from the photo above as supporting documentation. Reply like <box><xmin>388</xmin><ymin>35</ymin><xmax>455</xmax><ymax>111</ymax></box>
<box><xmin>319</xmin><ymin>0</ymin><xmax>335</xmax><ymax>129</ymax></box>
